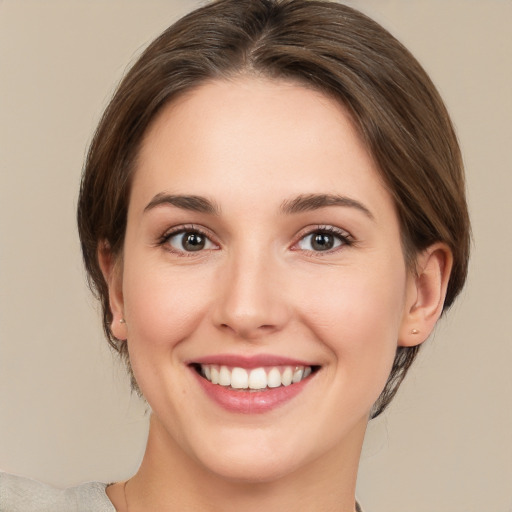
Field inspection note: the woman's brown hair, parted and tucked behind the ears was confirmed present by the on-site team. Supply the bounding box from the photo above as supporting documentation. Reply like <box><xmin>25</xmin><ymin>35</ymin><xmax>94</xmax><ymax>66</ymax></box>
<box><xmin>74</xmin><ymin>0</ymin><xmax>470</xmax><ymax>417</ymax></box>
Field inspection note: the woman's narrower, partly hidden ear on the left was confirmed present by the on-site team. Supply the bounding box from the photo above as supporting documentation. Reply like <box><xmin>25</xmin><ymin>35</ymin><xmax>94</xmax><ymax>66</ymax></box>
<box><xmin>98</xmin><ymin>240</ymin><xmax>128</xmax><ymax>340</ymax></box>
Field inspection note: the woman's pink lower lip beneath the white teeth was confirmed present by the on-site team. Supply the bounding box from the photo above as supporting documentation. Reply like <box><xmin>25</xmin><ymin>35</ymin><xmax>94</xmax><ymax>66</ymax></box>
<box><xmin>192</xmin><ymin>369</ymin><xmax>311</xmax><ymax>414</ymax></box>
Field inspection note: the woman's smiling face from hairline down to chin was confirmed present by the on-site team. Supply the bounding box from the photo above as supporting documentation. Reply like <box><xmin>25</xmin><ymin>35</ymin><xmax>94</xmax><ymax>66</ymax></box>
<box><xmin>111</xmin><ymin>78</ymin><xmax>411</xmax><ymax>481</ymax></box>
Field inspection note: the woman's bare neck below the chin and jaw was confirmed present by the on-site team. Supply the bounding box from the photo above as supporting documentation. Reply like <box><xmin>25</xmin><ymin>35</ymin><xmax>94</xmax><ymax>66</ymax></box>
<box><xmin>120</xmin><ymin>416</ymin><xmax>366</xmax><ymax>512</ymax></box>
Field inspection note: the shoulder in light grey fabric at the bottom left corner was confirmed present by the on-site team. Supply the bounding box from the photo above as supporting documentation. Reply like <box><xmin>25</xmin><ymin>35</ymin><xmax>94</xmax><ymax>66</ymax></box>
<box><xmin>0</xmin><ymin>473</ymin><xmax>115</xmax><ymax>512</ymax></box>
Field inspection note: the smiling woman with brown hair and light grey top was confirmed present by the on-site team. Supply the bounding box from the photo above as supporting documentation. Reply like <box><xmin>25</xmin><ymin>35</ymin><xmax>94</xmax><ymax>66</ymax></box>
<box><xmin>3</xmin><ymin>0</ymin><xmax>469</xmax><ymax>512</ymax></box>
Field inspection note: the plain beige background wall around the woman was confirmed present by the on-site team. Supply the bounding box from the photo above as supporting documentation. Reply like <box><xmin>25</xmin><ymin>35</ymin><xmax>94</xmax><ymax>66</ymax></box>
<box><xmin>0</xmin><ymin>0</ymin><xmax>512</xmax><ymax>512</ymax></box>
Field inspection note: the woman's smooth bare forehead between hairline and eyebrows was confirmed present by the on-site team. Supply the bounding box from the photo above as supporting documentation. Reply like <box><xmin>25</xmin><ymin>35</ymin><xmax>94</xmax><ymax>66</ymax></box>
<box><xmin>132</xmin><ymin>77</ymin><xmax>392</xmax><ymax>217</ymax></box>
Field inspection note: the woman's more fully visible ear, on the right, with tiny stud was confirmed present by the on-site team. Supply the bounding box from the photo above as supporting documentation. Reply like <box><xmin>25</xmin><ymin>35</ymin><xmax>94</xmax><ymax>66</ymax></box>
<box><xmin>398</xmin><ymin>243</ymin><xmax>453</xmax><ymax>347</ymax></box>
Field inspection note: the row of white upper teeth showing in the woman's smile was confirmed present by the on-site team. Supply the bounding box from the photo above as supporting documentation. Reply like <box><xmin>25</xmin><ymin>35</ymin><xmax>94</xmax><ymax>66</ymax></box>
<box><xmin>201</xmin><ymin>364</ymin><xmax>311</xmax><ymax>390</ymax></box>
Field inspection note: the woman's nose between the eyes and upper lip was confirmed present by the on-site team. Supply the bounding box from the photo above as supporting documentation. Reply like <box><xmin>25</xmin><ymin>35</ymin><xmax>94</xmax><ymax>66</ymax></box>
<box><xmin>214</xmin><ymin>247</ymin><xmax>291</xmax><ymax>340</ymax></box>
